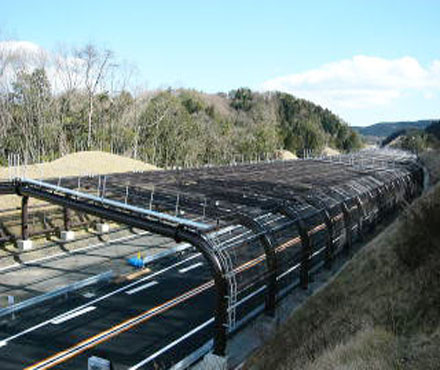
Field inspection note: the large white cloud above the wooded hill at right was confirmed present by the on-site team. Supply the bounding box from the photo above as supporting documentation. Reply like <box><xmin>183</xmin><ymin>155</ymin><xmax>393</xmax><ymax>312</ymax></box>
<box><xmin>261</xmin><ymin>55</ymin><xmax>440</xmax><ymax>113</ymax></box>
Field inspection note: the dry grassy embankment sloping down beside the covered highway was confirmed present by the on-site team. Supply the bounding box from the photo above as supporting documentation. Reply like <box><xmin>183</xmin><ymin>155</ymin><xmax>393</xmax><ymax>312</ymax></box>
<box><xmin>246</xmin><ymin>151</ymin><xmax>440</xmax><ymax>370</ymax></box>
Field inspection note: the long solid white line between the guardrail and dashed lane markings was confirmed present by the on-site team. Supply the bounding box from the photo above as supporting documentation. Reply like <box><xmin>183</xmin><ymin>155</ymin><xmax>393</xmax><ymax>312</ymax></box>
<box><xmin>0</xmin><ymin>253</ymin><xmax>201</xmax><ymax>343</ymax></box>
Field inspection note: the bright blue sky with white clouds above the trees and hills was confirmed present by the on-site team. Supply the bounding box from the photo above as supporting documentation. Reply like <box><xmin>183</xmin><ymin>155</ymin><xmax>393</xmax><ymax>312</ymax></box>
<box><xmin>0</xmin><ymin>0</ymin><xmax>440</xmax><ymax>125</ymax></box>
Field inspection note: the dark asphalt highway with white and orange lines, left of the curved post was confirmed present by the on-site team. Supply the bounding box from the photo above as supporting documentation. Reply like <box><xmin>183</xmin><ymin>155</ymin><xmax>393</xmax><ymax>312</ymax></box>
<box><xmin>0</xmin><ymin>249</ymin><xmax>214</xmax><ymax>369</ymax></box>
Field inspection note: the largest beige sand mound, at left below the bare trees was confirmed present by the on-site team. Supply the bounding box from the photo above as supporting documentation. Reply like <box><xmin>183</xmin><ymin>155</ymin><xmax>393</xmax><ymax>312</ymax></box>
<box><xmin>0</xmin><ymin>151</ymin><xmax>158</xmax><ymax>178</ymax></box>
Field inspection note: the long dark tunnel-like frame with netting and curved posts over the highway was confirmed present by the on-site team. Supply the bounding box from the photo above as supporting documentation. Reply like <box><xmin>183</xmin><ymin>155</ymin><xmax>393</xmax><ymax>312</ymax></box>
<box><xmin>1</xmin><ymin>150</ymin><xmax>423</xmax><ymax>355</ymax></box>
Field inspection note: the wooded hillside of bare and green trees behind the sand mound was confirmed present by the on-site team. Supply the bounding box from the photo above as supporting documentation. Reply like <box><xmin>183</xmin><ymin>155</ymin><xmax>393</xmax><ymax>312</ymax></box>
<box><xmin>0</xmin><ymin>45</ymin><xmax>361</xmax><ymax>167</ymax></box>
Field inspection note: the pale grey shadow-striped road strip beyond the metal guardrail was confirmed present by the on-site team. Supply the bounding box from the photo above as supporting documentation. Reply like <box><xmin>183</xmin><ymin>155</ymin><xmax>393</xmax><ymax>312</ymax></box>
<box><xmin>0</xmin><ymin>233</ymin><xmax>175</xmax><ymax>301</ymax></box>
